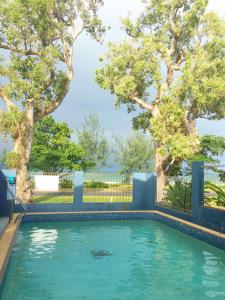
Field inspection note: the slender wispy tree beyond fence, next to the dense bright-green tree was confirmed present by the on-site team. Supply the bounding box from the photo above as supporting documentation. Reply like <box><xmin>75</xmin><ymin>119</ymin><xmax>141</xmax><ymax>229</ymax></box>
<box><xmin>77</xmin><ymin>113</ymin><xmax>110</xmax><ymax>169</ymax></box>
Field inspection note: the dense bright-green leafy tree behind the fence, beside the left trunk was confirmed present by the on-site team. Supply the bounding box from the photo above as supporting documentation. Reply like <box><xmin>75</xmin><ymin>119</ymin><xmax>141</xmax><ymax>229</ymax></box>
<box><xmin>29</xmin><ymin>116</ymin><xmax>89</xmax><ymax>172</ymax></box>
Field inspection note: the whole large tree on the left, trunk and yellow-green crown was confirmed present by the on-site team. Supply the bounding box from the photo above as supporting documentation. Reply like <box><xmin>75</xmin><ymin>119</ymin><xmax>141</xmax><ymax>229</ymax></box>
<box><xmin>0</xmin><ymin>0</ymin><xmax>104</xmax><ymax>201</ymax></box>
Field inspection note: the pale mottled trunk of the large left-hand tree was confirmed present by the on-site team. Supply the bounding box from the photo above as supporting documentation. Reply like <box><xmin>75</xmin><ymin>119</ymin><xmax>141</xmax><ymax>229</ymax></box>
<box><xmin>14</xmin><ymin>103</ymin><xmax>34</xmax><ymax>203</ymax></box>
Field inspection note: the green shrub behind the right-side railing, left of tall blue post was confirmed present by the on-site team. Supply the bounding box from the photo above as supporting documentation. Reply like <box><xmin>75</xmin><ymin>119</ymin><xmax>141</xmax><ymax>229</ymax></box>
<box><xmin>164</xmin><ymin>179</ymin><xmax>192</xmax><ymax>211</ymax></box>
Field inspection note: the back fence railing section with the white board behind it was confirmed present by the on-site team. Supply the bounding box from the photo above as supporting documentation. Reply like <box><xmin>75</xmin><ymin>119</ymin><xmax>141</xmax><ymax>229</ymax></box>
<box><xmin>29</xmin><ymin>172</ymin><xmax>74</xmax><ymax>204</ymax></box>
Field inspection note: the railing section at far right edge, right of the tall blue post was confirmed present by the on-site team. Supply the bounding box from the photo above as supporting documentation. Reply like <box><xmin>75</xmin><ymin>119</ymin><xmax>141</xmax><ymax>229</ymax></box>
<box><xmin>204</xmin><ymin>165</ymin><xmax>225</xmax><ymax>209</ymax></box>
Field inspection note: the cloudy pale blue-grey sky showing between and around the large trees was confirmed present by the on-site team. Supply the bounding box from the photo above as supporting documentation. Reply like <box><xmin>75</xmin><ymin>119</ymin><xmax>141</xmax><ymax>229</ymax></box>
<box><xmin>0</xmin><ymin>0</ymin><xmax>225</xmax><ymax>148</ymax></box>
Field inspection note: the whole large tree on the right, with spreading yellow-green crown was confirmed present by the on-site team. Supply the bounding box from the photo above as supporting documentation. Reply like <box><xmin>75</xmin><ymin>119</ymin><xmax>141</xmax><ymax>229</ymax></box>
<box><xmin>96</xmin><ymin>0</ymin><xmax>225</xmax><ymax>200</ymax></box>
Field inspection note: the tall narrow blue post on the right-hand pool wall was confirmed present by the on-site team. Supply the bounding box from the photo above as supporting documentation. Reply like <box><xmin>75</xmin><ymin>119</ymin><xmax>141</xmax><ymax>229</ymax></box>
<box><xmin>192</xmin><ymin>161</ymin><xmax>204</xmax><ymax>224</ymax></box>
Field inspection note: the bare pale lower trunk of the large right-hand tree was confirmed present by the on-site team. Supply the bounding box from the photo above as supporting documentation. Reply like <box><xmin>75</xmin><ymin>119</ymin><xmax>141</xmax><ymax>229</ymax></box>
<box><xmin>155</xmin><ymin>148</ymin><xmax>168</xmax><ymax>202</ymax></box>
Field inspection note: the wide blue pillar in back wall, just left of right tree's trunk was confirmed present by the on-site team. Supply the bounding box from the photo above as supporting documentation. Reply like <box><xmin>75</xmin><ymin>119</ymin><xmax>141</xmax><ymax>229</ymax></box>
<box><xmin>132</xmin><ymin>173</ymin><xmax>156</xmax><ymax>210</ymax></box>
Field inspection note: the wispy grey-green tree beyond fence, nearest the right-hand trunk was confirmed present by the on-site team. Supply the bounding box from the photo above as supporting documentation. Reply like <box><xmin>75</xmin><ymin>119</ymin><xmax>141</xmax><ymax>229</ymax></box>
<box><xmin>114</xmin><ymin>132</ymin><xmax>154</xmax><ymax>180</ymax></box>
